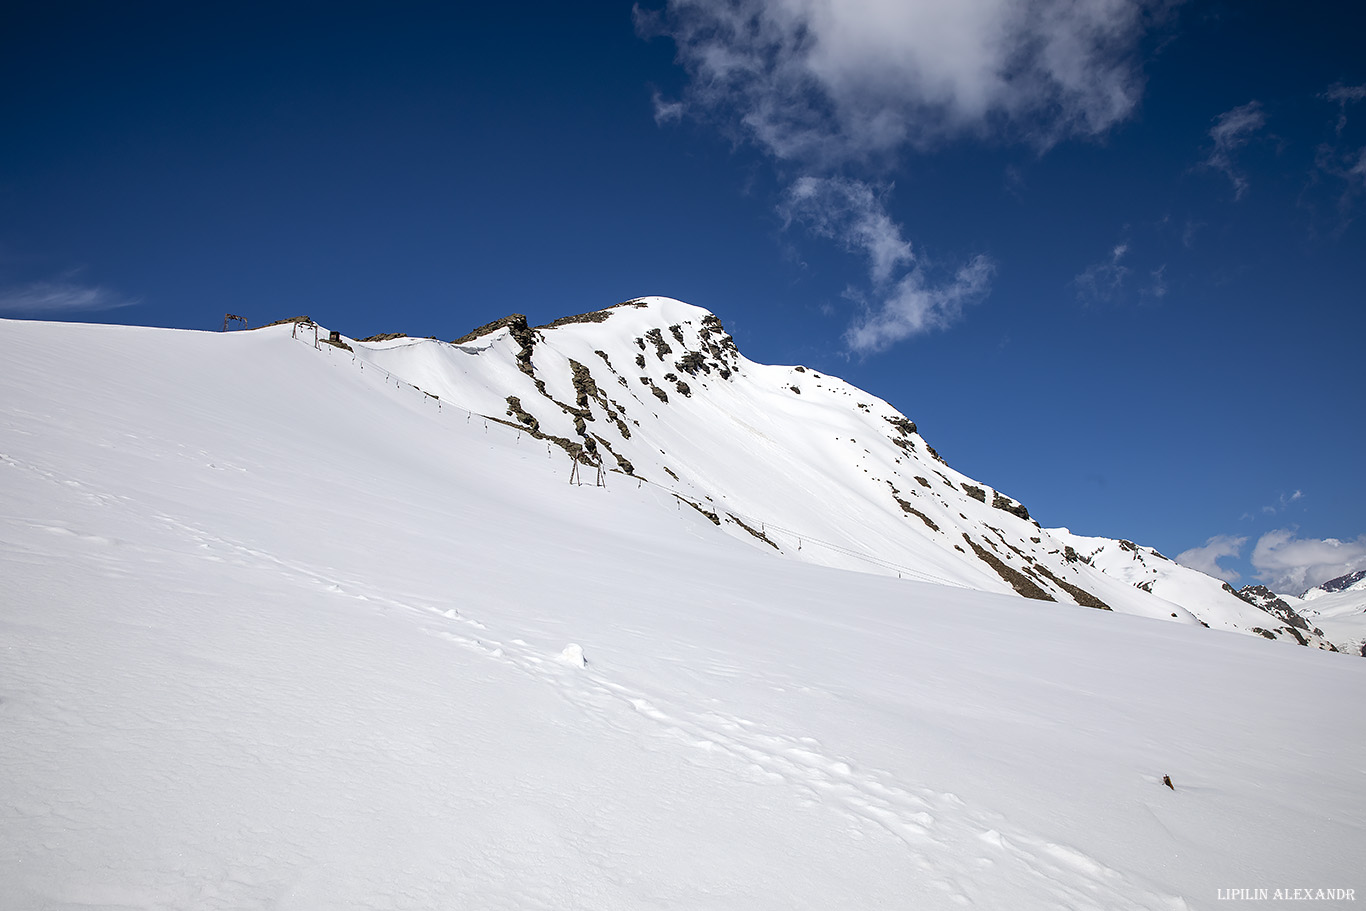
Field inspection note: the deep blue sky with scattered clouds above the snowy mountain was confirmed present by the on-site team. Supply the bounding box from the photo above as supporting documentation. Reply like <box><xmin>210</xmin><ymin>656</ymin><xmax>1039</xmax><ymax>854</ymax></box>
<box><xmin>0</xmin><ymin>0</ymin><xmax>1366</xmax><ymax>590</ymax></box>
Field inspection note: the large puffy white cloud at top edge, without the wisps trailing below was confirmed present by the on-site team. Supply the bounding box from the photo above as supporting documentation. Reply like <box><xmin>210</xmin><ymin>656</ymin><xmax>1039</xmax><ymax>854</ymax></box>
<box><xmin>637</xmin><ymin>0</ymin><xmax>1172</xmax><ymax>165</ymax></box>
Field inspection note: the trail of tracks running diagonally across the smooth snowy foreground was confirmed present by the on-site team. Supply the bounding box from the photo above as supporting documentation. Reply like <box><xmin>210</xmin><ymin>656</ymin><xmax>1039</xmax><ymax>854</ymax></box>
<box><xmin>37</xmin><ymin>464</ymin><xmax>1188</xmax><ymax>911</ymax></box>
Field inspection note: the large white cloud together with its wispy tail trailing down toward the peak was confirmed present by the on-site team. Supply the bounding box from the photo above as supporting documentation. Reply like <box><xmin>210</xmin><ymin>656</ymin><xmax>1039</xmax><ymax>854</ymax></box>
<box><xmin>635</xmin><ymin>0</ymin><xmax>1173</xmax><ymax>352</ymax></box>
